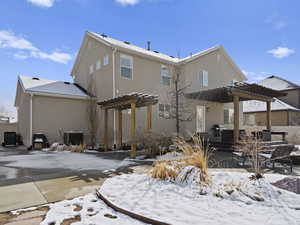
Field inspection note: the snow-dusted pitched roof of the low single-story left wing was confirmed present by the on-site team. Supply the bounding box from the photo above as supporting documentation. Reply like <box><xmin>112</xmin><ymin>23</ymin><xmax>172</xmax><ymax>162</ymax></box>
<box><xmin>19</xmin><ymin>76</ymin><xmax>89</xmax><ymax>99</ymax></box>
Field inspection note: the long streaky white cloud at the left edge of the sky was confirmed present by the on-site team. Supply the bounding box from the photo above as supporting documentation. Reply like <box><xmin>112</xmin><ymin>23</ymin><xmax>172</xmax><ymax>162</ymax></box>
<box><xmin>0</xmin><ymin>30</ymin><xmax>72</xmax><ymax>64</ymax></box>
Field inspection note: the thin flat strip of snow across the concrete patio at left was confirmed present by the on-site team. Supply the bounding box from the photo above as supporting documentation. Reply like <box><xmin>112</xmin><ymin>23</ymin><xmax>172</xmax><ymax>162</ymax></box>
<box><xmin>0</xmin><ymin>151</ymin><xmax>134</xmax><ymax>170</ymax></box>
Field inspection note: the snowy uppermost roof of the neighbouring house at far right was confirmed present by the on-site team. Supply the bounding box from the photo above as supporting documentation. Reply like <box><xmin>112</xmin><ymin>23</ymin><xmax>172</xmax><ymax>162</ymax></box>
<box><xmin>258</xmin><ymin>75</ymin><xmax>300</xmax><ymax>91</ymax></box>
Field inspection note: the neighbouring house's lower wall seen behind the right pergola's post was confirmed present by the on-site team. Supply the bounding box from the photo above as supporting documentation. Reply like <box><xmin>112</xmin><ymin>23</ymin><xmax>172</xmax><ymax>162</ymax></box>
<box><xmin>245</xmin><ymin>111</ymin><xmax>289</xmax><ymax>126</ymax></box>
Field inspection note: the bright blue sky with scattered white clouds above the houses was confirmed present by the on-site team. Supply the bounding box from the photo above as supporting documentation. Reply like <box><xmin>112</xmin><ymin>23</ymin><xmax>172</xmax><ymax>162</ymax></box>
<box><xmin>0</xmin><ymin>0</ymin><xmax>300</xmax><ymax>118</ymax></box>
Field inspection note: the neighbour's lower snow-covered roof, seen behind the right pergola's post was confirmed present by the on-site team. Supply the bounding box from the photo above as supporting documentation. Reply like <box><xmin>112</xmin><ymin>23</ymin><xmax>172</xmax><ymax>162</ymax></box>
<box><xmin>243</xmin><ymin>98</ymin><xmax>300</xmax><ymax>113</ymax></box>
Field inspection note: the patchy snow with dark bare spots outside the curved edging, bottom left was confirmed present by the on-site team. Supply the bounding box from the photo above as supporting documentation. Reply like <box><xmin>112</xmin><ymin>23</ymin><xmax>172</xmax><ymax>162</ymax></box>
<box><xmin>40</xmin><ymin>194</ymin><xmax>143</xmax><ymax>225</ymax></box>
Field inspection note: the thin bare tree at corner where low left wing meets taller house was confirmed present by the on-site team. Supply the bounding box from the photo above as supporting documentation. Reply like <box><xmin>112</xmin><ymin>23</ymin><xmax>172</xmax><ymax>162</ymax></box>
<box><xmin>87</xmin><ymin>76</ymin><xmax>99</xmax><ymax>148</ymax></box>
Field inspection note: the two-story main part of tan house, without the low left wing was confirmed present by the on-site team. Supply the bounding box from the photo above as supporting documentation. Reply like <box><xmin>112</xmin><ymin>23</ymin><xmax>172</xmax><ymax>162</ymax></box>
<box><xmin>71</xmin><ymin>32</ymin><xmax>246</xmax><ymax>148</ymax></box>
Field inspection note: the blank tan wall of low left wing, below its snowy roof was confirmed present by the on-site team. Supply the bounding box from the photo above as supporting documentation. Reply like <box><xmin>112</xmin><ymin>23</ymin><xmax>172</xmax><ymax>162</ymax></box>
<box><xmin>32</xmin><ymin>96</ymin><xmax>88</xmax><ymax>143</ymax></box>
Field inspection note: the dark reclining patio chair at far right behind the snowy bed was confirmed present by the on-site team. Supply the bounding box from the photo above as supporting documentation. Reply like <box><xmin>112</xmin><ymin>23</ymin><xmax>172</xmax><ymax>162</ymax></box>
<box><xmin>259</xmin><ymin>145</ymin><xmax>295</xmax><ymax>172</ymax></box>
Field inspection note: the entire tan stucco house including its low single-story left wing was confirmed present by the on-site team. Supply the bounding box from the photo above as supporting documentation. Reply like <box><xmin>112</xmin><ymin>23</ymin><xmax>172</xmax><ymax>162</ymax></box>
<box><xmin>16</xmin><ymin>32</ymin><xmax>246</xmax><ymax>146</ymax></box>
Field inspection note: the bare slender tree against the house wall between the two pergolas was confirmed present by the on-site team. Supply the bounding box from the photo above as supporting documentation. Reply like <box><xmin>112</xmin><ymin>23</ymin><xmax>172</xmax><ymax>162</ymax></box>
<box><xmin>169</xmin><ymin>67</ymin><xmax>192</xmax><ymax>136</ymax></box>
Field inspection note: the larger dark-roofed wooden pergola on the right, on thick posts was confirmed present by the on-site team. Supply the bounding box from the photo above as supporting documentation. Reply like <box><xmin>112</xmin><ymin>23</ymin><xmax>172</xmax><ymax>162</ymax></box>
<box><xmin>186</xmin><ymin>82</ymin><xmax>286</xmax><ymax>144</ymax></box>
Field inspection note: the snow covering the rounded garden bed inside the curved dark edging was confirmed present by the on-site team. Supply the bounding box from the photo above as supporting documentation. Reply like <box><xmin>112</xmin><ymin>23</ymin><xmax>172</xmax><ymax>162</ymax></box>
<box><xmin>100</xmin><ymin>172</ymin><xmax>300</xmax><ymax>225</ymax></box>
